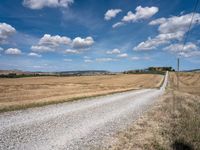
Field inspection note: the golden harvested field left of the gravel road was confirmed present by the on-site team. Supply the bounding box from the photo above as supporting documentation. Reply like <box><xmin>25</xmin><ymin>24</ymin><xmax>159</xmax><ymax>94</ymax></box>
<box><xmin>0</xmin><ymin>74</ymin><xmax>163</xmax><ymax>111</ymax></box>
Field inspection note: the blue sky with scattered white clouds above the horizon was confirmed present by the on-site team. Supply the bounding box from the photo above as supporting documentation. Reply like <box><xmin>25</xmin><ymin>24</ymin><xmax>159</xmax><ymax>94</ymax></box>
<box><xmin>0</xmin><ymin>0</ymin><xmax>200</xmax><ymax>71</ymax></box>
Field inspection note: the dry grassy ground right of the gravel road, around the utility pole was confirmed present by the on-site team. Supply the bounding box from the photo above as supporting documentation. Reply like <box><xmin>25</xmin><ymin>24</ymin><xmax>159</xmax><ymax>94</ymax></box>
<box><xmin>106</xmin><ymin>73</ymin><xmax>200</xmax><ymax>150</ymax></box>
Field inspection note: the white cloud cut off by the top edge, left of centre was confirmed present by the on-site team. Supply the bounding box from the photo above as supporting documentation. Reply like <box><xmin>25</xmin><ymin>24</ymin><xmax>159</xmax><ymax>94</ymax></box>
<box><xmin>23</xmin><ymin>0</ymin><xmax>74</xmax><ymax>9</ymax></box>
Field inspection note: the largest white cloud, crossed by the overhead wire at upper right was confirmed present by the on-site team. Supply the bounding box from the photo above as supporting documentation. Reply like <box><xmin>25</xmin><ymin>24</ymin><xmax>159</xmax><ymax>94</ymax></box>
<box><xmin>133</xmin><ymin>13</ymin><xmax>200</xmax><ymax>50</ymax></box>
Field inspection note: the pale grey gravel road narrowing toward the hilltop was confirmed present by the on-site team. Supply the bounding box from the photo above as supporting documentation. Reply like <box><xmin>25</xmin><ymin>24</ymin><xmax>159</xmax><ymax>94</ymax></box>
<box><xmin>0</xmin><ymin>74</ymin><xmax>168</xmax><ymax>150</ymax></box>
